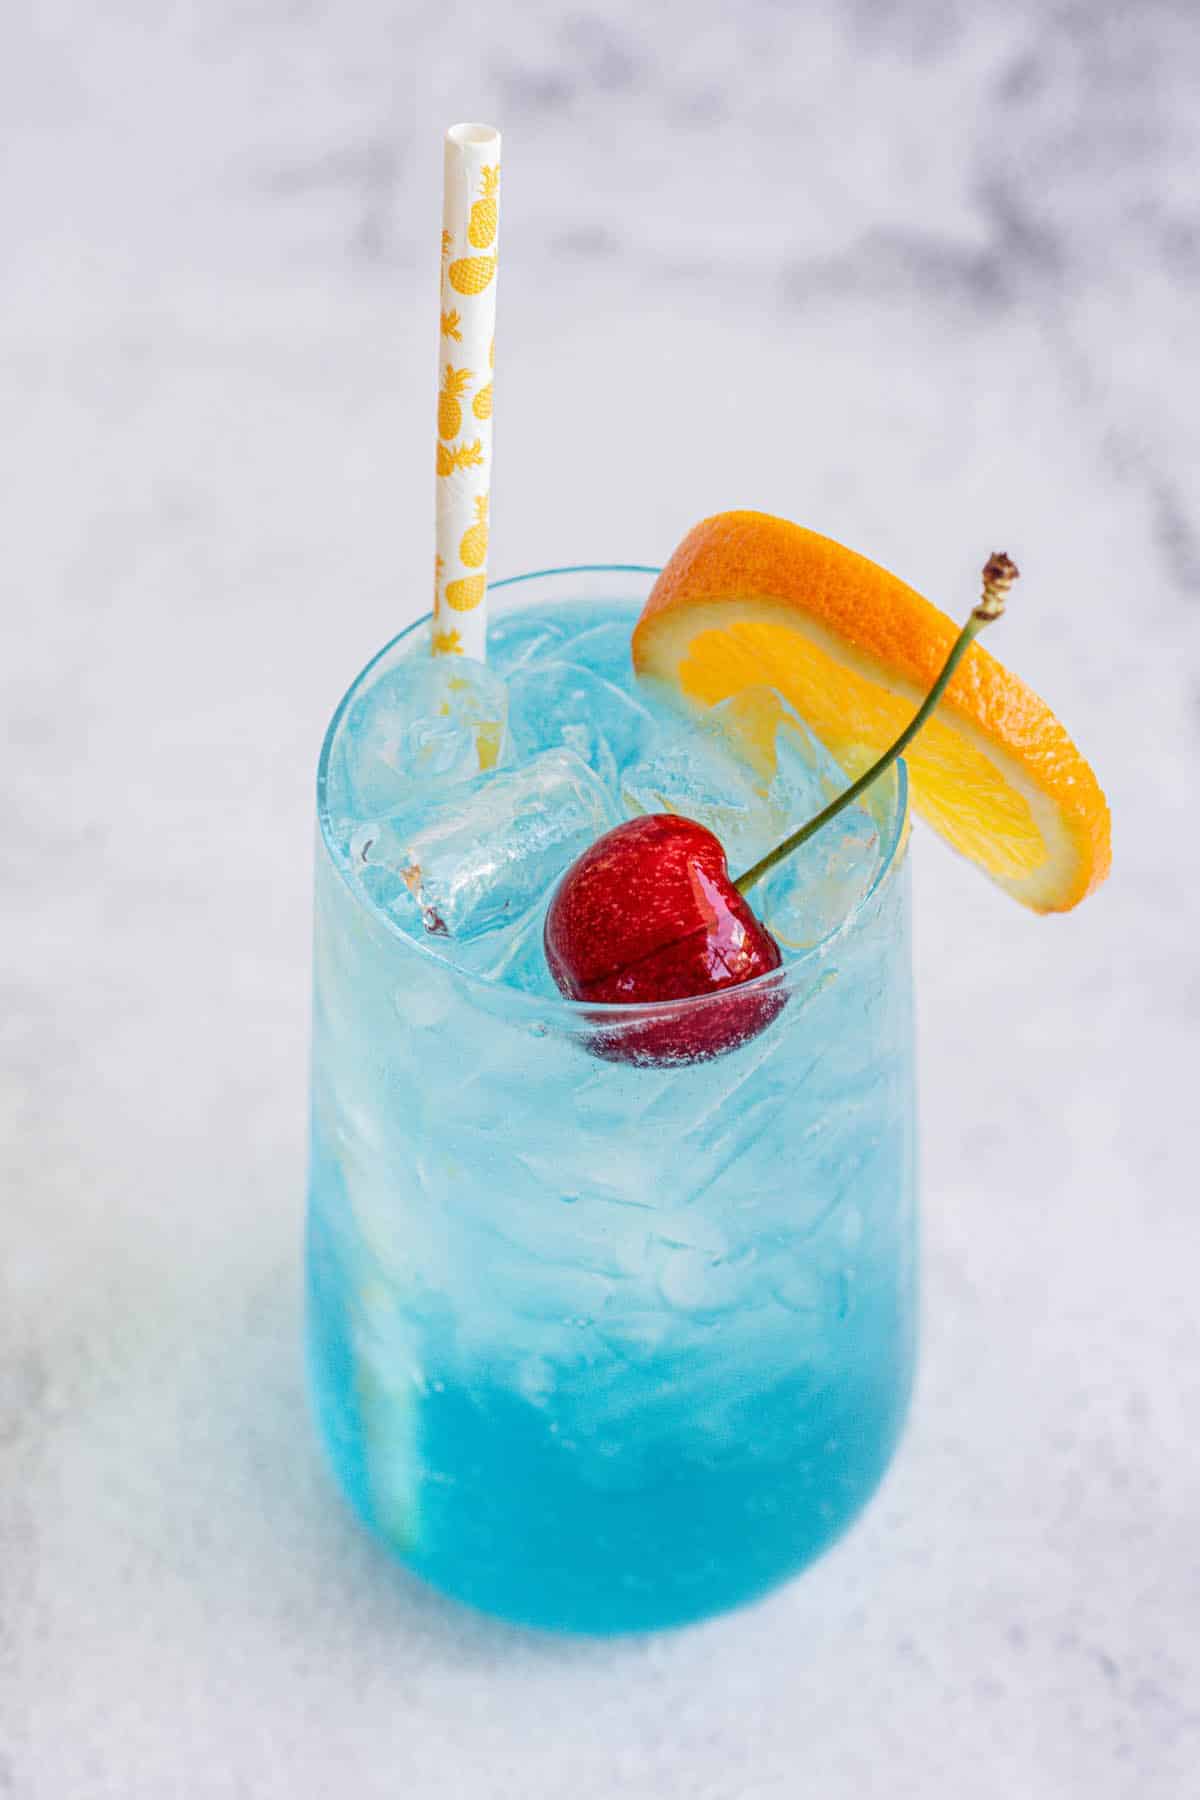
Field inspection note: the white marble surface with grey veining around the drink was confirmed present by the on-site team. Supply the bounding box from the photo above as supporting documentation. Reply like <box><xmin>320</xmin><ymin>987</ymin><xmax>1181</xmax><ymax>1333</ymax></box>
<box><xmin>0</xmin><ymin>0</ymin><xmax>1200</xmax><ymax>1800</ymax></box>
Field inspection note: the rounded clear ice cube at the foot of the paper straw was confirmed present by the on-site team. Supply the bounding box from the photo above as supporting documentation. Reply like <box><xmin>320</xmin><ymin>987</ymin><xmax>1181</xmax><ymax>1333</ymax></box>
<box><xmin>331</xmin><ymin>655</ymin><xmax>507</xmax><ymax>821</ymax></box>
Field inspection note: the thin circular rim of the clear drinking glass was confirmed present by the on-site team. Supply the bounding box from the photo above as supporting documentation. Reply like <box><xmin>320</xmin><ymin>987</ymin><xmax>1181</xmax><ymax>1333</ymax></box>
<box><xmin>317</xmin><ymin>563</ymin><xmax>910</xmax><ymax>1031</ymax></box>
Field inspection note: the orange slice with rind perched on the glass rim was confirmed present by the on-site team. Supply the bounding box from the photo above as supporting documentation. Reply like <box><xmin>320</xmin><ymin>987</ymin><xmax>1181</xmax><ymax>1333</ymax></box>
<box><xmin>633</xmin><ymin>513</ymin><xmax>1110</xmax><ymax>913</ymax></box>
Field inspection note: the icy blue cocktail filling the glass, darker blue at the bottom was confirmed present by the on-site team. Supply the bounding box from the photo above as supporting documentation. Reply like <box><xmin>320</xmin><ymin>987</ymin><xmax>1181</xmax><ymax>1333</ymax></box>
<box><xmin>309</xmin><ymin>569</ymin><xmax>916</xmax><ymax>1633</ymax></box>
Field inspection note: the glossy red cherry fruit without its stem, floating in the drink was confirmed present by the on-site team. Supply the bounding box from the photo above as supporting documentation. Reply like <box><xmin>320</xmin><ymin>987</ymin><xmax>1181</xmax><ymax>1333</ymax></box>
<box><xmin>545</xmin><ymin>814</ymin><xmax>784</xmax><ymax>1064</ymax></box>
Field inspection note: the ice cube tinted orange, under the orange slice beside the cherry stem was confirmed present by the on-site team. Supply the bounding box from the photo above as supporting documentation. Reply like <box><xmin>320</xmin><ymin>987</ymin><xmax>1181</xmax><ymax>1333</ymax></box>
<box><xmin>621</xmin><ymin>688</ymin><xmax>840</xmax><ymax>875</ymax></box>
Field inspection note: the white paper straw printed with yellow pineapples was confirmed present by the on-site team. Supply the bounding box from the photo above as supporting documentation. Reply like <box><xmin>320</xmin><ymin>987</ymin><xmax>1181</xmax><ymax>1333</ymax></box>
<box><xmin>434</xmin><ymin>124</ymin><xmax>500</xmax><ymax>662</ymax></box>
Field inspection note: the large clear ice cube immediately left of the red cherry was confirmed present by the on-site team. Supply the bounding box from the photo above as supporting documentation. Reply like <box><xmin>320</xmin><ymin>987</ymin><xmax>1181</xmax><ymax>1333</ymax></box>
<box><xmin>353</xmin><ymin>749</ymin><xmax>619</xmax><ymax>940</ymax></box>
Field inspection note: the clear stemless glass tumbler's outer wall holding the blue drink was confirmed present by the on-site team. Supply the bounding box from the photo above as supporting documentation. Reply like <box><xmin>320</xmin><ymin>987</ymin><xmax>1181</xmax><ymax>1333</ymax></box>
<box><xmin>308</xmin><ymin>567</ymin><xmax>916</xmax><ymax>1633</ymax></box>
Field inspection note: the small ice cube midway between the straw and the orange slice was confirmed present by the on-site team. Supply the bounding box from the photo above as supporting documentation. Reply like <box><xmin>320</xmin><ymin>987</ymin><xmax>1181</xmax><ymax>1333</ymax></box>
<box><xmin>509</xmin><ymin>662</ymin><xmax>655</xmax><ymax>792</ymax></box>
